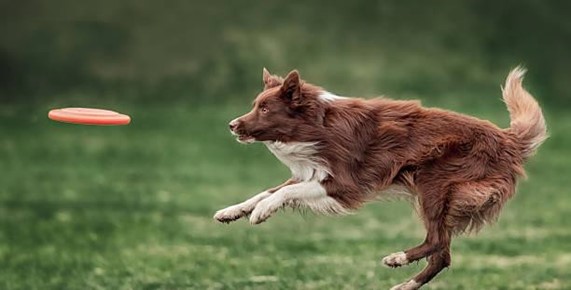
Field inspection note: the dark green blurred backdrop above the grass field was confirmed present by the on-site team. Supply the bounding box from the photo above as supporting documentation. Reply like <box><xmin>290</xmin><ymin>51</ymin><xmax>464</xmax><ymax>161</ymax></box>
<box><xmin>0</xmin><ymin>0</ymin><xmax>571</xmax><ymax>105</ymax></box>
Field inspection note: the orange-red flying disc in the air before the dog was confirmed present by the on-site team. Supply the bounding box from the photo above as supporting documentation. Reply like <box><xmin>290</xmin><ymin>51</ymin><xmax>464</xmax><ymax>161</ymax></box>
<box><xmin>48</xmin><ymin>108</ymin><xmax>131</xmax><ymax>126</ymax></box>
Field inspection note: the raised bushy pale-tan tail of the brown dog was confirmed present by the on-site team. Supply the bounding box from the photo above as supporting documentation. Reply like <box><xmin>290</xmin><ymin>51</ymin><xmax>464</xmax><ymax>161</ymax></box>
<box><xmin>502</xmin><ymin>66</ymin><xmax>547</xmax><ymax>158</ymax></box>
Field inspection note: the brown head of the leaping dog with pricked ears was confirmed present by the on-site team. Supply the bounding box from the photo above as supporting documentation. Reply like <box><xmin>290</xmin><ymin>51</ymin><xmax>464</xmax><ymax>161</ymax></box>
<box><xmin>229</xmin><ymin>68</ymin><xmax>323</xmax><ymax>143</ymax></box>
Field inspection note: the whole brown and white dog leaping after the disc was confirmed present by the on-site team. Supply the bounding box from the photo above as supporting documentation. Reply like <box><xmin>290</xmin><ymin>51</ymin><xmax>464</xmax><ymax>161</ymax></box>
<box><xmin>214</xmin><ymin>68</ymin><xmax>547</xmax><ymax>289</ymax></box>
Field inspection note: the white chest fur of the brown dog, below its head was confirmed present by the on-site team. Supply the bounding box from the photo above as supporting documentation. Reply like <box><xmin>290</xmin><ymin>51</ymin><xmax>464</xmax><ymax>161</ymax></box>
<box><xmin>264</xmin><ymin>142</ymin><xmax>329</xmax><ymax>181</ymax></box>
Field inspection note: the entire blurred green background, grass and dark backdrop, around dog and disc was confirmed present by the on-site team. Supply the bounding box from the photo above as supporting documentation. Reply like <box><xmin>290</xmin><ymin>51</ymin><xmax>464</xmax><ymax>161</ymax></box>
<box><xmin>0</xmin><ymin>0</ymin><xmax>571</xmax><ymax>289</ymax></box>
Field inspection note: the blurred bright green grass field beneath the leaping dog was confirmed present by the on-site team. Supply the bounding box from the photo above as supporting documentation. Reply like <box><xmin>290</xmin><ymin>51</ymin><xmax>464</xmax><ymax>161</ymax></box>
<box><xmin>0</xmin><ymin>100</ymin><xmax>571</xmax><ymax>289</ymax></box>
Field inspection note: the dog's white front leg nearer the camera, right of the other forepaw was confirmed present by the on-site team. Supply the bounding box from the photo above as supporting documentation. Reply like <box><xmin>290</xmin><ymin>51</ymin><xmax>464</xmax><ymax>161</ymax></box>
<box><xmin>250</xmin><ymin>180</ymin><xmax>348</xmax><ymax>224</ymax></box>
